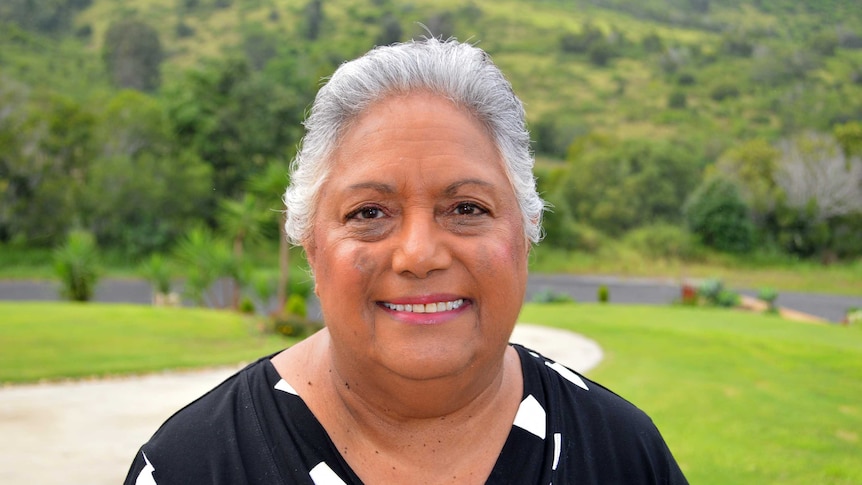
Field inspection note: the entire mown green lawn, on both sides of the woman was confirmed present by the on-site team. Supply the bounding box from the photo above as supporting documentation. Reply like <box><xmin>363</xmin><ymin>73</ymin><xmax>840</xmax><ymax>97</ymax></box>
<box><xmin>0</xmin><ymin>303</ymin><xmax>862</xmax><ymax>484</ymax></box>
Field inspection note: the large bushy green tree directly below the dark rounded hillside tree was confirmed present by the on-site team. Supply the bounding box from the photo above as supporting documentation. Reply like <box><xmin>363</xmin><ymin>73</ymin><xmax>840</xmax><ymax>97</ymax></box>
<box><xmin>80</xmin><ymin>91</ymin><xmax>213</xmax><ymax>256</ymax></box>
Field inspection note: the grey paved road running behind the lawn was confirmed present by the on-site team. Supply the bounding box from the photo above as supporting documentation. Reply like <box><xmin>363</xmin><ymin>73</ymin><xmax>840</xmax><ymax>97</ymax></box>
<box><xmin>0</xmin><ymin>274</ymin><xmax>862</xmax><ymax>322</ymax></box>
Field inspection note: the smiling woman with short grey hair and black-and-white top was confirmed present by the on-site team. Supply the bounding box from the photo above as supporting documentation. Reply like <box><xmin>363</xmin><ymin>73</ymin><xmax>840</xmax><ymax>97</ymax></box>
<box><xmin>126</xmin><ymin>39</ymin><xmax>685</xmax><ymax>485</ymax></box>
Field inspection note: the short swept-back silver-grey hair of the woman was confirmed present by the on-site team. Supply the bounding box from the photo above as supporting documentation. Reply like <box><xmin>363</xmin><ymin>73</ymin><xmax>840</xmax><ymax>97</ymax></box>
<box><xmin>284</xmin><ymin>37</ymin><xmax>545</xmax><ymax>245</ymax></box>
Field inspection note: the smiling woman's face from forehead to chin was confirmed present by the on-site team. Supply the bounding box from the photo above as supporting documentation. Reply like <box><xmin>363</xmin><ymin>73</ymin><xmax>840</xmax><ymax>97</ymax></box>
<box><xmin>306</xmin><ymin>93</ymin><xmax>529</xmax><ymax>379</ymax></box>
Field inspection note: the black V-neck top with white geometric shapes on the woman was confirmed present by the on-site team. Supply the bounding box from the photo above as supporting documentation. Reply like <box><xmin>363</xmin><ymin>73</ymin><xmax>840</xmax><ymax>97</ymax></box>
<box><xmin>125</xmin><ymin>345</ymin><xmax>687</xmax><ymax>485</ymax></box>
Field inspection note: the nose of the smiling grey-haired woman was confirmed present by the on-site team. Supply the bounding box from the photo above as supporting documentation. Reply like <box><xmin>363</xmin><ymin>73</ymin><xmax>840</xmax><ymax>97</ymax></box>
<box><xmin>392</xmin><ymin>214</ymin><xmax>452</xmax><ymax>278</ymax></box>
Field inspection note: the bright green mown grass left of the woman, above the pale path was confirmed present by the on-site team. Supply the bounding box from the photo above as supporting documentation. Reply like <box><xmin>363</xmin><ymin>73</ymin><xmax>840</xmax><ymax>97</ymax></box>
<box><xmin>0</xmin><ymin>302</ymin><xmax>293</xmax><ymax>383</ymax></box>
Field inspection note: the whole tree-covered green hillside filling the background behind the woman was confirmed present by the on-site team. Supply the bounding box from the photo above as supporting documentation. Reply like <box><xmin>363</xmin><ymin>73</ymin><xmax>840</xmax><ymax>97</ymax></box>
<box><xmin>0</xmin><ymin>0</ymin><xmax>862</xmax><ymax>268</ymax></box>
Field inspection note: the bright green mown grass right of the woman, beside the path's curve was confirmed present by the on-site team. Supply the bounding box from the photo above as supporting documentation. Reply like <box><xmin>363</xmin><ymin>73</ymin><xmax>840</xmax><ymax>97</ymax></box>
<box><xmin>521</xmin><ymin>304</ymin><xmax>862</xmax><ymax>484</ymax></box>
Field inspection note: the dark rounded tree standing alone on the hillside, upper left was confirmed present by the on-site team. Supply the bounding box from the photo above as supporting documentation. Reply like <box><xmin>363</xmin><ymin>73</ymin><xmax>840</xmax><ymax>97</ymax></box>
<box><xmin>102</xmin><ymin>19</ymin><xmax>164</xmax><ymax>91</ymax></box>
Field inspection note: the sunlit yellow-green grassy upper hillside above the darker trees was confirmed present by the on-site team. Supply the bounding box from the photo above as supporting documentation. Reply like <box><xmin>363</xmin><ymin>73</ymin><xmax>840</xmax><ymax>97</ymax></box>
<box><xmin>2</xmin><ymin>0</ymin><xmax>862</xmax><ymax>147</ymax></box>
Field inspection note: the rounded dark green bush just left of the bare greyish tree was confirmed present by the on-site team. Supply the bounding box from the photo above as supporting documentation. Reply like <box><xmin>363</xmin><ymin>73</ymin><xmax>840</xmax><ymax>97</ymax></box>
<box><xmin>685</xmin><ymin>177</ymin><xmax>754</xmax><ymax>253</ymax></box>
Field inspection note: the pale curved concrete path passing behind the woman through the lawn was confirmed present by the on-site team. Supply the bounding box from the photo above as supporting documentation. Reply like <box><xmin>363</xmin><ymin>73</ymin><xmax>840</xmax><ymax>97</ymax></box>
<box><xmin>0</xmin><ymin>324</ymin><xmax>602</xmax><ymax>485</ymax></box>
